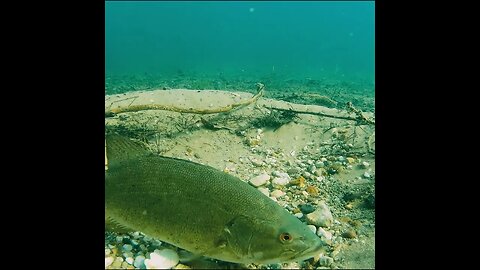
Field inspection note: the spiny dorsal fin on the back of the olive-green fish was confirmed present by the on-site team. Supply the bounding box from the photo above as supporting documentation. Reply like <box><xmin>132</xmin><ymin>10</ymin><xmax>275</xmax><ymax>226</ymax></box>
<box><xmin>105</xmin><ymin>134</ymin><xmax>150</xmax><ymax>162</ymax></box>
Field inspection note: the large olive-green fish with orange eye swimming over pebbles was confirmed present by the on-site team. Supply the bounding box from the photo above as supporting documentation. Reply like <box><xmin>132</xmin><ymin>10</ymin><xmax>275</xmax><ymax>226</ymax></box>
<box><xmin>105</xmin><ymin>135</ymin><xmax>323</xmax><ymax>264</ymax></box>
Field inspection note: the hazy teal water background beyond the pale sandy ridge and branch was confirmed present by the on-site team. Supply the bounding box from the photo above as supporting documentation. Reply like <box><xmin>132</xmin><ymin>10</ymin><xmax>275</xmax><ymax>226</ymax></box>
<box><xmin>105</xmin><ymin>1</ymin><xmax>375</xmax><ymax>111</ymax></box>
